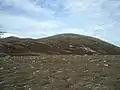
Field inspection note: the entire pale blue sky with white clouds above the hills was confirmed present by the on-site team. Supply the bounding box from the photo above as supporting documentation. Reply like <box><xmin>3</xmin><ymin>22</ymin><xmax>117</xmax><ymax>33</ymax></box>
<box><xmin>0</xmin><ymin>0</ymin><xmax>120</xmax><ymax>46</ymax></box>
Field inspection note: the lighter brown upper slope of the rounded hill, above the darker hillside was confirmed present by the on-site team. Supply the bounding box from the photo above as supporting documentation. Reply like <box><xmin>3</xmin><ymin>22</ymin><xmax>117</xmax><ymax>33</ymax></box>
<box><xmin>39</xmin><ymin>34</ymin><xmax>120</xmax><ymax>54</ymax></box>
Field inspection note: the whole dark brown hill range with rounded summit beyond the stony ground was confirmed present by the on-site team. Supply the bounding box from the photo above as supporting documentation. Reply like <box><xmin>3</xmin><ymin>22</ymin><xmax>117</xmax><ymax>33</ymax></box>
<box><xmin>0</xmin><ymin>33</ymin><xmax>120</xmax><ymax>55</ymax></box>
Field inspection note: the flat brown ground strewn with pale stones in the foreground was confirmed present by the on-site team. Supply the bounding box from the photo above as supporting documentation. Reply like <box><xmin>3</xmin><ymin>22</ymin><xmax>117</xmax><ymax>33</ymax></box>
<box><xmin>0</xmin><ymin>54</ymin><xmax>120</xmax><ymax>90</ymax></box>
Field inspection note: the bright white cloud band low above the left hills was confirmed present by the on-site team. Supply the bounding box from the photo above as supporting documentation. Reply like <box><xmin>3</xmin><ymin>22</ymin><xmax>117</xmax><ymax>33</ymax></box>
<box><xmin>0</xmin><ymin>14</ymin><xmax>62</xmax><ymax>36</ymax></box>
